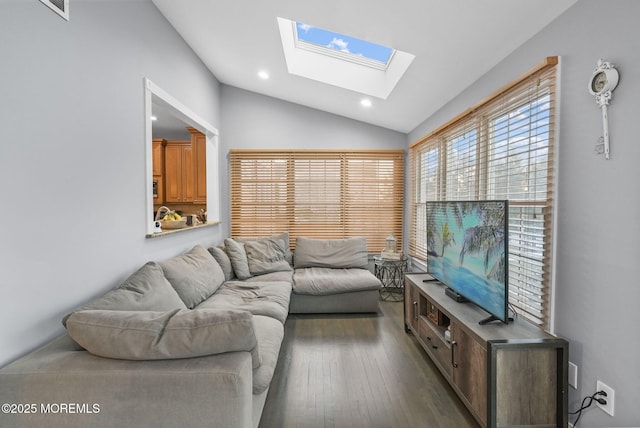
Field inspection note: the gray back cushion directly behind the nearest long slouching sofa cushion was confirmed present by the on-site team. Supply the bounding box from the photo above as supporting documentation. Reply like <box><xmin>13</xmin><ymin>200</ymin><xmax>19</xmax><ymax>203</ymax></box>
<box><xmin>62</xmin><ymin>262</ymin><xmax>186</xmax><ymax>325</ymax></box>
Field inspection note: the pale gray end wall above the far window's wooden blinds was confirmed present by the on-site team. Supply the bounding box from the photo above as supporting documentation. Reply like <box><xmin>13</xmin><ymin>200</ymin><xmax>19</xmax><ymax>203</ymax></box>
<box><xmin>220</xmin><ymin>85</ymin><xmax>406</xmax><ymax>234</ymax></box>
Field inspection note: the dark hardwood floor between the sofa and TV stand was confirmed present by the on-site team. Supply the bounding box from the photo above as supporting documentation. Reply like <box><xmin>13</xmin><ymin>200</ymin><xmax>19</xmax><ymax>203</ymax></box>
<box><xmin>260</xmin><ymin>302</ymin><xmax>478</xmax><ymax>428</ymax></box>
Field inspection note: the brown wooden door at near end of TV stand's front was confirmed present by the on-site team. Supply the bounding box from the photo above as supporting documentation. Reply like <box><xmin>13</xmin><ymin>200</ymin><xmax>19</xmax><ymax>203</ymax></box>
<box><xmin>451</xmin><ymin>322</ymin><xmax>487</xmax><ymax>421</ymax></box>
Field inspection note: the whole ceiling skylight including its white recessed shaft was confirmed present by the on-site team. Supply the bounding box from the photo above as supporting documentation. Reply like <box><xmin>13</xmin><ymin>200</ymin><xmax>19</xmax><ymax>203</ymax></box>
<box><xmin>278</xmin><ymin>17</ymin><xmax>415</xmax><ymax>99</ymax></box>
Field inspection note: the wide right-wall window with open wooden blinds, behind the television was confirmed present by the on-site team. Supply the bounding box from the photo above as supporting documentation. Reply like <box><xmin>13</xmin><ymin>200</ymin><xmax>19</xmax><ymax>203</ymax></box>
<box><xmin>409</xmin><ymin>57</ymin><xmax>557</xmax><ymax>328</ymax></box>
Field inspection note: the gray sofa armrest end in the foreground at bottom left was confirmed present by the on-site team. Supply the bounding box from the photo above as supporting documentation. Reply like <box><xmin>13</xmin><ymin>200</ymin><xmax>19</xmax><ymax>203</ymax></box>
<box><xmin>0</xmin><ymin>335</ymin><xmax>253</xmax><ymax>428</ymax></box>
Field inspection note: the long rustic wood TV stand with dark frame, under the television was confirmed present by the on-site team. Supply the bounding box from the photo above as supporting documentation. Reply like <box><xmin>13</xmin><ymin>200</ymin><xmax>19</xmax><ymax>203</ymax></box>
<box><xmin>404</xmin><ymin>273</ymin><xmax>569</xmax><ymax>428</ymax></box>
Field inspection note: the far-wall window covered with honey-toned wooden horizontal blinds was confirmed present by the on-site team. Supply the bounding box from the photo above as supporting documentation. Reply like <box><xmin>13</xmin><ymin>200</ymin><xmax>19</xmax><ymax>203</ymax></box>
<box><xmin>229</xmin><ymin>150</ymin><xmax>404</xmax><ymax>253</ymax></box>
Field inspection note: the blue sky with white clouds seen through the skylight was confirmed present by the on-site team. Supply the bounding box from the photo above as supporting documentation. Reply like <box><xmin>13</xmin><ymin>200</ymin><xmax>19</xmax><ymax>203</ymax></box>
<box><xmin>296</xmin><ymin>22</ymin><xmax>393</xmax><ymax>64</ymax></box>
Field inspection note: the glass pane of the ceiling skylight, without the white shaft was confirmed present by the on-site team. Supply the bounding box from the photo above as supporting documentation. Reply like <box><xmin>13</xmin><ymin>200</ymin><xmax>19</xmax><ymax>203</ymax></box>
<box><xmin>294</xmin><ymin>22</ymin><xmax>394</xmax><ymax>69</ymax></box>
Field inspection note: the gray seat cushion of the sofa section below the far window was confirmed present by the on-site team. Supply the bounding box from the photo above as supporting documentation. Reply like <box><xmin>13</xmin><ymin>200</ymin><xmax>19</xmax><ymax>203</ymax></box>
<box><xmin>293</xmin><ymin>267</ymin><xmax>381</xmax><ymax>296</ymax></box>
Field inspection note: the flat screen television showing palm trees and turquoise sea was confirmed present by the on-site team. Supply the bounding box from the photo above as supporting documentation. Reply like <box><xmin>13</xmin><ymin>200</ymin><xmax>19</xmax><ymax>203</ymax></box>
<box><xmin>426</xmin><ymin>200</ymin><xmax>509</xmax><ymax>324</ymax></box>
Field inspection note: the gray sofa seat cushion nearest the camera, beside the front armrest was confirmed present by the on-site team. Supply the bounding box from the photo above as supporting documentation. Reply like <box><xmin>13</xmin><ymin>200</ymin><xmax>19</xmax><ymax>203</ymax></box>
<box><xmin>253</xmin><ymin>315</ymin><xmax>284</xmax><ymax>394</ymax></box>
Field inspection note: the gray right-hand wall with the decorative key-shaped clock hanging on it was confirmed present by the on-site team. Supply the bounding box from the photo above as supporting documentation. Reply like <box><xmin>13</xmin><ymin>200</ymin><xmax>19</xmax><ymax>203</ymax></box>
<box><xmin>409</xmin><ymin>0</ymin><xmax>640</xmax><ymax>428</ymax></box>
